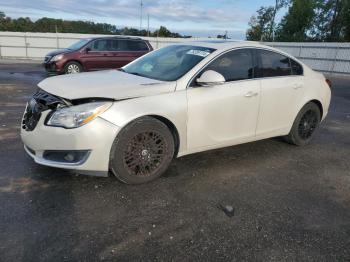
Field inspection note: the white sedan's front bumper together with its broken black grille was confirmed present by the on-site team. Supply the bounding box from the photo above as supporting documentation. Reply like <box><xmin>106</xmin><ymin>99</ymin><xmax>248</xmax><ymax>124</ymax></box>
<box><xmin>21</xmin><ymin>89</ymin><xmax>120</xmax><ymax>176</ymax></box>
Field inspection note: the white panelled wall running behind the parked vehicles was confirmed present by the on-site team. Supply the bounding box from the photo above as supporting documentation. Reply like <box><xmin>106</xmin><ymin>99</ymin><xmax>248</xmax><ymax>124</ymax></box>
<box><xmin>0</xmin><ymin>32</ymin><xmax>350</xmax><ymax>74</ymax></box>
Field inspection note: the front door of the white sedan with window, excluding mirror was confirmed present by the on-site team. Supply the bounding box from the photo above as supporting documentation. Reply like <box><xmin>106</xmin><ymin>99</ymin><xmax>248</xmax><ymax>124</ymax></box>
<box><xmin>187</xmin><ymin>49</ymin><xmax>260</xmax><ymax>151</ymax></box>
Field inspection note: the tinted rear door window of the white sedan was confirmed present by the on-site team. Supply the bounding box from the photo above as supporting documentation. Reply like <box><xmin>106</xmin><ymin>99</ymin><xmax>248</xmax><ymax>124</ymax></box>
<box><xmin>258</xmin><ymin>50</ymin><xmax>292</xmax><ymax>77</ymax></box>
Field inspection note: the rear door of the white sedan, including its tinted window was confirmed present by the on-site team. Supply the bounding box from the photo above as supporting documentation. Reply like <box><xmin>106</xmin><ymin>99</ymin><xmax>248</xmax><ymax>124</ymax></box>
<box><xmin>255</xmin><ymin>49</ymin><xmax>304</xmax><ymax>136</ymax></box>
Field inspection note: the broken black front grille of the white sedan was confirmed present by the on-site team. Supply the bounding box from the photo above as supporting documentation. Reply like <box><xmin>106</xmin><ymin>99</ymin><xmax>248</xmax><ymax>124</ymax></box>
<box><xmin>22</xmin><ymin>89</ymin><xmax>64</xmax><ymax>131</ymax></box>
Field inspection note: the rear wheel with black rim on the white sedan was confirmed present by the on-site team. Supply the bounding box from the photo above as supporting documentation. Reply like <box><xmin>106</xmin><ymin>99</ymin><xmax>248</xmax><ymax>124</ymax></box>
<box><xmin>285</xmin><ymin>102</ymin><xmax>321</xmax><ymax>146</ymax></box>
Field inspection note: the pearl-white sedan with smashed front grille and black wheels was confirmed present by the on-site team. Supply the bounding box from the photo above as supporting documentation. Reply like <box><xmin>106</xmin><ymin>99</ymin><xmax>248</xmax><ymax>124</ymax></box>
<box><xmin>21</xmin><ymin>41</ymin><xmax>331</xmax><ymax>184</ymax></box>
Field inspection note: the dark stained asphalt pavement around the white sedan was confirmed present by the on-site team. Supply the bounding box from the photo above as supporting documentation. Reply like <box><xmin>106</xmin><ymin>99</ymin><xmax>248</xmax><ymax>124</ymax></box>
<box><xmin>0</xmin><ymin>62</ymin><xmax>350</xmax><ymax>262</ymax></box>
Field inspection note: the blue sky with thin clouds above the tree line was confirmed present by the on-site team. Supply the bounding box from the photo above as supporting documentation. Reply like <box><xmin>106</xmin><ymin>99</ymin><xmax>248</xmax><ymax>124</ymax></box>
<box><xmin>0</xmin><ymin>0</ymin><xmax>284</xmax><ymax>39</ymax></box>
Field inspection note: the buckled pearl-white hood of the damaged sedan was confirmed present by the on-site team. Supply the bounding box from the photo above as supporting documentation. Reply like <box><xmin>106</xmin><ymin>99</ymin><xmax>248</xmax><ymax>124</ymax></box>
<box><xmin>38</xmin><ymin>70</ymin><xmax>176</xmax><ymax>100</ymax></box>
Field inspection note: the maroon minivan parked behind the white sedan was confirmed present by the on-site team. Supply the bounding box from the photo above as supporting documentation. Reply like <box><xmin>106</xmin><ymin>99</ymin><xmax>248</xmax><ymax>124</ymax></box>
<box><xmin>44</xmin><ymin>37</ymin><xmax>153</xmax><ymax>74</ymax></box>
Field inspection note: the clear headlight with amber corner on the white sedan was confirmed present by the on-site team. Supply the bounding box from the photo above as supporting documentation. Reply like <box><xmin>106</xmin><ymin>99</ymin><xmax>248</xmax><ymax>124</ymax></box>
<box><xmin>46</xmin><ymin>102</ymin><xmax>112</xmax><ymax>128</ymax></box>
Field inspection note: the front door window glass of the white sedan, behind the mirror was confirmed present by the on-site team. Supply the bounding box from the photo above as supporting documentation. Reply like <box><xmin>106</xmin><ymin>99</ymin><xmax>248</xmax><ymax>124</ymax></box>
<box><xmin>204</xmin><ymin>49</ymin><xmax>254</xmax><ymax>82</ymax></box>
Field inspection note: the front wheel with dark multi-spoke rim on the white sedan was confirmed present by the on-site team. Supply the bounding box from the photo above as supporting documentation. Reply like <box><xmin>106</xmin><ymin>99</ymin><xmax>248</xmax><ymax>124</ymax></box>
<box><xmin>110</xmin><ymin>117</ymin><xmax>175</xmax><ymax>184</ymax></box>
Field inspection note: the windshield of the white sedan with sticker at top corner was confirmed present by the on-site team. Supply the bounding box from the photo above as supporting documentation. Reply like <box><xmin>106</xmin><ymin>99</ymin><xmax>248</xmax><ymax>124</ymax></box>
<box><xmin>123</xmin><ymin>45</ymin><xmax>215</xmax><ymax>81</ymax></box>
